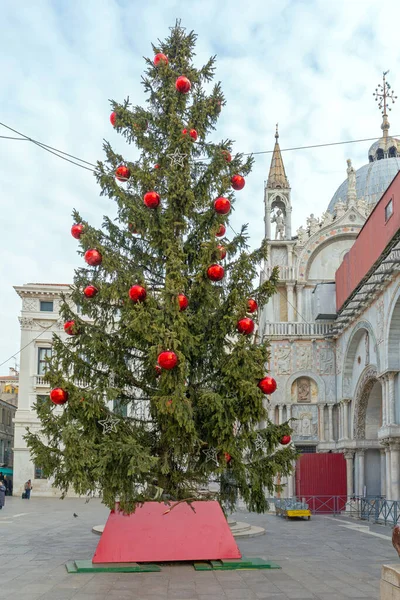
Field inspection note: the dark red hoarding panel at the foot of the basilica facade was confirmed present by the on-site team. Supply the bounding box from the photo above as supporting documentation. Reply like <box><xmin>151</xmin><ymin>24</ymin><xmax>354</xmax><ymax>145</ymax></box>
<box><xmin>296</xmin><ymin>453</ymin><xmax>347</xmax><ymax>513</ymax></box>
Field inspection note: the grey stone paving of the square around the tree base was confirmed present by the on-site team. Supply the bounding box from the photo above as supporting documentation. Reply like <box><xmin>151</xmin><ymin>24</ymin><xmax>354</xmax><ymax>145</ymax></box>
<box><xmin>0</xmin><ymin>494</ymin><xmax>398</xmax><ymax>600</ymax></box>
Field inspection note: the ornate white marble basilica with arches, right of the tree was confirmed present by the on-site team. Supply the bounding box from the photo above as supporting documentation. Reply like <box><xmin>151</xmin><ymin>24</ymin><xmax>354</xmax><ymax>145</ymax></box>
<box><xmin>259</xmin><ymin>76</ymin><xmax>400</xmax><ymax>499</ymax></box>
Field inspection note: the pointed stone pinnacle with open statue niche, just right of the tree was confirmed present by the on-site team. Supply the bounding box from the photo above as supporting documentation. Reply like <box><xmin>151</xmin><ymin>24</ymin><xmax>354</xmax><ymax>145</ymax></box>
<box><xmin>264</xmin><ymin>125</ymin><xmax>292</xmax><ymax>240</ymax></box>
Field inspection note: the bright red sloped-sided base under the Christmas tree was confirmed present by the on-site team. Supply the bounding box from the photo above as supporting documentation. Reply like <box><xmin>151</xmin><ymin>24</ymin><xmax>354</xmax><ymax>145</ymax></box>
<box><xmin>92</xmin><ymin>500</ymin><xmax>242</xmax><ymax>563</ymax></box>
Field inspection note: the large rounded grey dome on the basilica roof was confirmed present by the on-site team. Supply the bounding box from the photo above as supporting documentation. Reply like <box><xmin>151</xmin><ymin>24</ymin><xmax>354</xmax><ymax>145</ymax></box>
<box><xmin>328</xmin><ymin>158</ymin><xmax>400</xmax><ymax>213</ymax></box>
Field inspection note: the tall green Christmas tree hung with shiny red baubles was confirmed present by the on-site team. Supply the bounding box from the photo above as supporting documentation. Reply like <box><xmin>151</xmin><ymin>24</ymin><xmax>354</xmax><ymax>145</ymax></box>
<box><xmin>26</xmin><ymin>22</ymin><xmax>296</xmax><ymax>512</ymax></box>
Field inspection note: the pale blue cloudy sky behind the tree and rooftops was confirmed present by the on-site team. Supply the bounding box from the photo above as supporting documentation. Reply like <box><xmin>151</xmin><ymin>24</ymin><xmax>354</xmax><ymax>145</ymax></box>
<box><xmin>0</xmin><ymin>0</ymin><xmax>400</xmax><ymax>374</ymax></box>
